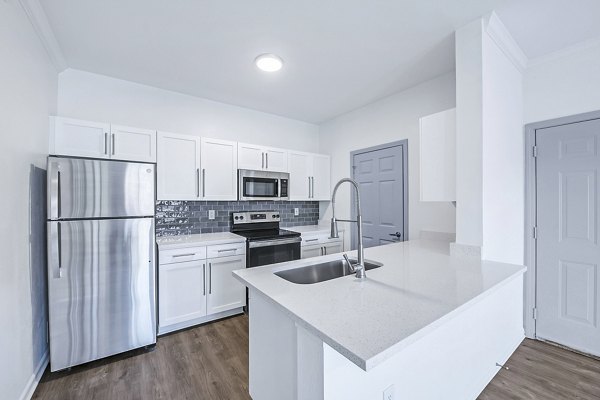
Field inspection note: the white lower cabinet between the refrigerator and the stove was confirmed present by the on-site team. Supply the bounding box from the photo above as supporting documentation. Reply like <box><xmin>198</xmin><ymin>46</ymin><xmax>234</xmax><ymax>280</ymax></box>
<box><xmin>158</xmin><ymin>243</ymin><xmax>246</xmax><ymax>335</ymax></box>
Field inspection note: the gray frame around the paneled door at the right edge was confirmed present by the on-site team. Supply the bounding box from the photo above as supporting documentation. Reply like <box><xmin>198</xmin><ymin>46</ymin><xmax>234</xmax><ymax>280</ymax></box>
<box><xmin>523</xmin><ymin>111</ymin><xmax>600</xmax><ymax>339</ymax></box>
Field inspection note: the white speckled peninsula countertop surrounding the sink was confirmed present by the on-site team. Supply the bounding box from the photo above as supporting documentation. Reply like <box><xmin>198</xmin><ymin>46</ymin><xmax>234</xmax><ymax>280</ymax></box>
<box><xmin>234</xmin><ymin>240</ymin><xmax>525</xmax><ymax>371</ymax></box>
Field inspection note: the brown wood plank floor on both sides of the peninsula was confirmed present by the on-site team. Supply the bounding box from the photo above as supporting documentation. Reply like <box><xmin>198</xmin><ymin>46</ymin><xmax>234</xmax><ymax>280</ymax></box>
<box><xmin>33</xmin><ymin>316</ymin><xmax>600</xmax><ymax>400</ymax></box>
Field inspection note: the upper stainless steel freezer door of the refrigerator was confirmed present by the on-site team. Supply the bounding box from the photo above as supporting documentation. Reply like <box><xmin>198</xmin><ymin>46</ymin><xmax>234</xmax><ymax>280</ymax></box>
<box><xmin>48</xmin><ymin>157</ymin><xmax>155</xmax><ymax>220</ymax></box>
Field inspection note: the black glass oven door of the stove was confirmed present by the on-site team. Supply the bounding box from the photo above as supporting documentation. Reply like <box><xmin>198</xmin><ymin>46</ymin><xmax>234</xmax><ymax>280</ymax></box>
<box><xmin>246</xmin><ymin>237</ymin><xmax>302</xmax><ymax>268</ymax></box>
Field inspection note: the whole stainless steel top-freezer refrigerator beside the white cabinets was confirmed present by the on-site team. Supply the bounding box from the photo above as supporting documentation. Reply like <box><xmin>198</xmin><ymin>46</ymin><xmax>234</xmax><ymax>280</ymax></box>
<box><xmin>47</xmin><ymin>156</ymin><xmax>156</xmax><ymax>371</ymax></box>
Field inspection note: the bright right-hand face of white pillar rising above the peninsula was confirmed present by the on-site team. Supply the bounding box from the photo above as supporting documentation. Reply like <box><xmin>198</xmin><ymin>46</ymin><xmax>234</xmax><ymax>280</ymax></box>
<box><xmin>481</xmin><ymin>20</ymin><xmax>525</xmax><ymax>265</ymax></box>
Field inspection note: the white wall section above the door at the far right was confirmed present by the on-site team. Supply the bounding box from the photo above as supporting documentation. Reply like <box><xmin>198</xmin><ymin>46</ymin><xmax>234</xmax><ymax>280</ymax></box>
<box><xmin>524</xmin><ymin>40</ymin><xmax>600</xmax><ymax>123</ymax></box>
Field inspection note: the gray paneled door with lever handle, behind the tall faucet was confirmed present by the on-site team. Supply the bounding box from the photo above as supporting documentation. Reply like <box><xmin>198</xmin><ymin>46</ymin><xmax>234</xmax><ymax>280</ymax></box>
<box><xmin>352</xmin><ymin>145</ymin><xmax>405</xmax><ymax>247</ymax></box>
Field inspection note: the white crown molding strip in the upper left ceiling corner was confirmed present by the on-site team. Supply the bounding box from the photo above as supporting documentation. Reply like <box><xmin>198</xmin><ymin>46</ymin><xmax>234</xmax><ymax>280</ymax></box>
<box><xmin>19</xmin><ymin>0</ymin><xmax>68</xmax><ymax>72</ymax></box>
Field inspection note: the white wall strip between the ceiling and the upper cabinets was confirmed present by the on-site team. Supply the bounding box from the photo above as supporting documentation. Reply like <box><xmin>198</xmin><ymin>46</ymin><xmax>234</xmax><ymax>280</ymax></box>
<box><xmin>58</xmin><ymin>69</ymin><xmax>319</xmax><ymax>151</ymax></box>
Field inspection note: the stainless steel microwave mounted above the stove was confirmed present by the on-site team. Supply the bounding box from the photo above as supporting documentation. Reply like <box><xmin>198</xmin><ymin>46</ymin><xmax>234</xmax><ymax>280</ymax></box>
<box><xmin>238</xmin><ymin>169</ymin><xmax>290</xmax><ymax>200</ymax></box>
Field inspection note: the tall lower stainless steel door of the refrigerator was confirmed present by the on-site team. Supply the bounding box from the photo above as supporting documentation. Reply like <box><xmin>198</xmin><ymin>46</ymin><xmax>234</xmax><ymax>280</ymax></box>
<box><xmin>48</xmin><ymin>218</ymin><xmax>156</xmax><ymax>371</ymax></box>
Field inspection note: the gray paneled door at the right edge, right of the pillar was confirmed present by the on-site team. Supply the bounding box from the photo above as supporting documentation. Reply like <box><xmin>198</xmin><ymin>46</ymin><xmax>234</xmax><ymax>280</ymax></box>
<box><xmin>536</xmin><ymin>120</ymin><xmax>600</xmax><ymax>355</ymax></box>
